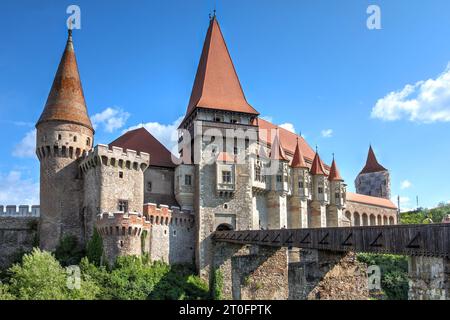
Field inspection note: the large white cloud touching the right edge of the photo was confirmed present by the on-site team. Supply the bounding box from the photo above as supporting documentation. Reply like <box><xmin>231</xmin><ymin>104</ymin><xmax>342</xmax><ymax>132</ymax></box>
<box><xmin>371</xmin><ymin>64</ymin><xmax>450</xmax><ymax>123</ymax></box>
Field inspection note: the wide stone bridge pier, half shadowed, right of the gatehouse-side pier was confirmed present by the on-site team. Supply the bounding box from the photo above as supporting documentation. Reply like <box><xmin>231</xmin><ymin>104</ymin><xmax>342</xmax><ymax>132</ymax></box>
<box><xmin>289</xmin><ymin>249</ymin><xmax>369</xmax><ymax>300</ymax></box>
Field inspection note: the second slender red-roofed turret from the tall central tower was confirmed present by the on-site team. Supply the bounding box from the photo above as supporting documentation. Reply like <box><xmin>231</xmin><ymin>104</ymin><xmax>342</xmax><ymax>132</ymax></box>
<box><xmin>288</xmin><ymin>138</ymin><xmax>311</xmax><ymax>228</ymax></box>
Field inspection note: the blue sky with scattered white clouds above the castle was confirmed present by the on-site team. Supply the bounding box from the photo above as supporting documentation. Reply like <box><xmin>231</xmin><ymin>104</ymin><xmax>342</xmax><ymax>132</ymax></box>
<box><xmin>0</xmin><ymin>0</ymin><xmax>450</xmax><ymax>208</ymax></box>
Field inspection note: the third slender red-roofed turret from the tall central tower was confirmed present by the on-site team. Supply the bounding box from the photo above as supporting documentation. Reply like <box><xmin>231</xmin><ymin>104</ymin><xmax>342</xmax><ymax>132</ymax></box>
<box><xmin>309</xmin><ymin>150</ymin><xmax>328</xmax><ymax>228</ymax></box>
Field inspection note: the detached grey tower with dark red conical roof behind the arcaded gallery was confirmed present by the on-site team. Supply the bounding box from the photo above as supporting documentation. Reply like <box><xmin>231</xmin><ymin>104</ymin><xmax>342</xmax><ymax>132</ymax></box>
<box><xmin>355</xmin><ymin>146</ymin><xmax>391</xmax><ymax>199</ymax></box>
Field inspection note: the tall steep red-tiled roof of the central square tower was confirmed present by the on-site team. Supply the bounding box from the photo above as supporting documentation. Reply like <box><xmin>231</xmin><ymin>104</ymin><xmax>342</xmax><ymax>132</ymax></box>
<box><xmin>181</xmin><ymin>14</ymin><xmax>258</xmax><ymax>124</ymax></box>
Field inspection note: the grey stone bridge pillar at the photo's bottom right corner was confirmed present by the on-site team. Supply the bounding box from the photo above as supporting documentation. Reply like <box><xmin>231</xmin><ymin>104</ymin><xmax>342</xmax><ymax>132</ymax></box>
<box><xmin>408</xmin><ymin>256</ymin><xmax>450</xmax><ymax>300</ymax></box>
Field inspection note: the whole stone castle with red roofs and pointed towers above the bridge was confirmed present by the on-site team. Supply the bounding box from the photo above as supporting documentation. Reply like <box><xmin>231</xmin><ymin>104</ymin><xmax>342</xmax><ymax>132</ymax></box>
<box><xmin>0</xmin><ymin>16</ymin><xmax>397</xmax><ymax>277</ymax></box>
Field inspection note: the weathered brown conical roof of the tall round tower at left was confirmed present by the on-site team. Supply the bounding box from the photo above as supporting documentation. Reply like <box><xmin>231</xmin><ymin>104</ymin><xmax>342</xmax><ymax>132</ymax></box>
<box><xmin>36</xmin><ymin>29</ymin><xmax>93</xmax><ymax>130</ymax></box>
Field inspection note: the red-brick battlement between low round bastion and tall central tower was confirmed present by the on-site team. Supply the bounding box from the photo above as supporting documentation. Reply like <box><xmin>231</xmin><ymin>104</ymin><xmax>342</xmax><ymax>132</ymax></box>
<box><xmin>143</xmin><ymin>203</ymin><xmax>195</xmax><ymax>226</ymax></box>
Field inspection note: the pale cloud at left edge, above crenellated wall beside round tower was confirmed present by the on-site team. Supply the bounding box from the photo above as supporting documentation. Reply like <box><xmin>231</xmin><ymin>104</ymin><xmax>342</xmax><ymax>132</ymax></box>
<box><xmin>0</xmin><ymin>170</ymin><xmax>39</xmax><ymax>205</ymax></box>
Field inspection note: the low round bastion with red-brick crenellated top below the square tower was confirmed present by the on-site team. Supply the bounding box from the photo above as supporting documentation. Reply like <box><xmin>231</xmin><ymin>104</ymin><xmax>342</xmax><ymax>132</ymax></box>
<box><xmin>96</xmin><ymin>212</ymin><xmax>151</xmax><ymax>265</ymax></box>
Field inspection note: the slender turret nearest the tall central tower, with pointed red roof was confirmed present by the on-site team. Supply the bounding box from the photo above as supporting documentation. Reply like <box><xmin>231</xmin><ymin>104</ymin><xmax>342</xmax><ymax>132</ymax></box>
<box><xmin>267</xmin><ymin>133</ymin><xmax>289</xmax><ymax>229</ymax></box>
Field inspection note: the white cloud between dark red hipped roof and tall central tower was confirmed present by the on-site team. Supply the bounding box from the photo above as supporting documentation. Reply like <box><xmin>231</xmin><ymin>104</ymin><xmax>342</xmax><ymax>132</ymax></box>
<box><xmin>123</xmin><ymin>117</ymin><xmax>184</xmax><ymax>155</ymax></box>
